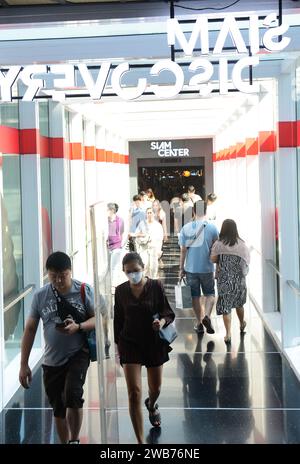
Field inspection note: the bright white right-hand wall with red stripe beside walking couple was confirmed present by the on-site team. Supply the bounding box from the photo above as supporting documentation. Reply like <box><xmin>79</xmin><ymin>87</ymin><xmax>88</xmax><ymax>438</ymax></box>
<box><xmin>214</xmin><ymin>81</ymin><xmax>278</xmax><ymax>336</ymax></box>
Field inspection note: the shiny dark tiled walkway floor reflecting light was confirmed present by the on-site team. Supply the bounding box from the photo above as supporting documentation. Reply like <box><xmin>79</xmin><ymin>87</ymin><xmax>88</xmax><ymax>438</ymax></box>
<box><xmin>1</xmin><ymin>240</ymin><xmax>300</xmax><ymax>444</ymax></box>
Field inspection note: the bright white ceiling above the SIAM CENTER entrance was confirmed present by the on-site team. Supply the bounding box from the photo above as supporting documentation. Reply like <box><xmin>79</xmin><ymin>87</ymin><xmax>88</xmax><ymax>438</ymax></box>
<box><xmin>68</xmin><ymin>89</ymin><xmax>251</xmax><ymax>140</ymax></box>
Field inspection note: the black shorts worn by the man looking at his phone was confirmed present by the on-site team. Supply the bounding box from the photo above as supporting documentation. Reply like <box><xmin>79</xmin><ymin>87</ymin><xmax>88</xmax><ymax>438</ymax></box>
<box><xmin>42</xmin><ymin>350</ymin><xmax>90</xmax><ymax>419</ymax></box>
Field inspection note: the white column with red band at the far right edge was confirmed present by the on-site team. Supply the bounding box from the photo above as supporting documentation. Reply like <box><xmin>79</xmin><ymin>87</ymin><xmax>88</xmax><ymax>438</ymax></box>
<box><xmin>276</xmin><ymin>70</ymin><xmax>300</xmax><ymax>348</ymax></box>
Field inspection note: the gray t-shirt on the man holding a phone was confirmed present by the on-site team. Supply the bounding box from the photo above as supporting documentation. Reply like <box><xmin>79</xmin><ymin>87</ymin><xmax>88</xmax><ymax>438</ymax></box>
<box><xmin>29</xmin><ymin>279</ymin><xmax>94</xmax><ymax>366</ymax></box>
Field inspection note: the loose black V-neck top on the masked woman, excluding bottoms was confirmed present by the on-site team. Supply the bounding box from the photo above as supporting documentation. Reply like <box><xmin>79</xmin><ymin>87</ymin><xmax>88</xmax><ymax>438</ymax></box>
<box><xmin>114</xmin><ymin>278</ymin><xmax>175</xmax><ymax>346</ymax></box>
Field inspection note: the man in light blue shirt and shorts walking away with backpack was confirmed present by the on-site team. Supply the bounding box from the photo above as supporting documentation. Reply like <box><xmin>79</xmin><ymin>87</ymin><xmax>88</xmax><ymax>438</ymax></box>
<box><xmin>179</xmin><ymin>200</ymin><xmax>219</xmax><ymax>334</ymax></box>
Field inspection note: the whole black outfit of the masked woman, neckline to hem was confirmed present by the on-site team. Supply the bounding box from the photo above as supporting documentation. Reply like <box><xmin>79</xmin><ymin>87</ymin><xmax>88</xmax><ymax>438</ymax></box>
<box><xmin>114</xmin><ymin>278</ymin><xmax>175</xmax><ymax>367</ymax></box>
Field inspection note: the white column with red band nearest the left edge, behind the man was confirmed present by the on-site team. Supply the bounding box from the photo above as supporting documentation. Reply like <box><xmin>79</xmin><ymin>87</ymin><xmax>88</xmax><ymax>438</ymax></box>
<box><xmin>13</xmin><ymin>102</ymin><xmax>43</xmax><ymax>400</ymax></box>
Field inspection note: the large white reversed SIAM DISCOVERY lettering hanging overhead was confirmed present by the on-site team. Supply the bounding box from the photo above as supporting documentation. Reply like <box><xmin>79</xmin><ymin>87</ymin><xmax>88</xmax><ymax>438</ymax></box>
<box><xmin>0</xmin><ymin>13</ymin><xmax>291</xmax><ymax>102</ymax></box>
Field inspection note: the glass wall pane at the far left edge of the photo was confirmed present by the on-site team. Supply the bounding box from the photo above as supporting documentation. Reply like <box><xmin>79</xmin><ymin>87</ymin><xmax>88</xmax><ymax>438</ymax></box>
<box><xmin>0</xmin><ymin>103</ymin><xmax>24</xmax><ymax>365</ymax></box>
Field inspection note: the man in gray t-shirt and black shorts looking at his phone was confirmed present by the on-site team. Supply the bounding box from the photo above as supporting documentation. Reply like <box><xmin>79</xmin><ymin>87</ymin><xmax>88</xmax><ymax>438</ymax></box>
<box><xmin>19</xmin><ymin>251</ymin><xmax>95</xmax><ymax>443</ymax></box>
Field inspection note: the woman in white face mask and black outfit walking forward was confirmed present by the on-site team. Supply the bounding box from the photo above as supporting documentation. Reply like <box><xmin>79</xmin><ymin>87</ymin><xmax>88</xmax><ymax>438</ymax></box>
<box><xmin>114</xmin><ymin>253</ymin><xmax>175</xmax><ymax>443</ymax></box>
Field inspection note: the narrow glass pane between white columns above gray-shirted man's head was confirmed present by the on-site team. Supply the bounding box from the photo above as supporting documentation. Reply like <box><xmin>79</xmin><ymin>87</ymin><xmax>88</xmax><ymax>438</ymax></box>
<box><xmin>39</xmin><ymin>102</ymin><xmax>52</xmax><ymax>266</ymax></box>
